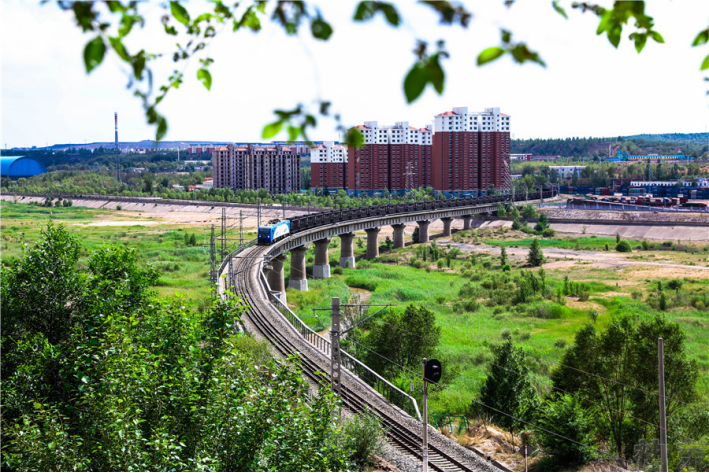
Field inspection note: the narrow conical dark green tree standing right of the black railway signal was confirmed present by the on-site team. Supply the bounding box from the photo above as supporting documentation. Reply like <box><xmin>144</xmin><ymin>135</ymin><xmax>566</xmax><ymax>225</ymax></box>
<box><xmin>480</xmin><ymin>339</ymin><xmax>539</xmax><ymax>430</ymax></box>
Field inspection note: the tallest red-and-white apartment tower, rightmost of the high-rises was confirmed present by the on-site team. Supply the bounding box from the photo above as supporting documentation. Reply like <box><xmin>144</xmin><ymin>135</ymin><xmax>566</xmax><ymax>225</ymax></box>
<box><xmin>432</xmin><ymin>107</ymin><xmax>510</xmax><ymax>195</ymax></box>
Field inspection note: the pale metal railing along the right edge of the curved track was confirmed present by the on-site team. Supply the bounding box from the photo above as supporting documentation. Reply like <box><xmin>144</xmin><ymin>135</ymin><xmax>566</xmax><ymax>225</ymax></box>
<box><xmin>261</xmin><ymin>272</ymin><xmax>421</xmax><ymax>420</ymax></box>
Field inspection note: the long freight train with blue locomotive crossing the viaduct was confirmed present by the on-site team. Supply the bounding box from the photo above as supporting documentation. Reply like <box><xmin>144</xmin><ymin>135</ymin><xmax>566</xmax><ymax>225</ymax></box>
<box><xmin>257</xmin><ymin>191</ymin><xmax>556</xmax><ymax>245</ymax></box>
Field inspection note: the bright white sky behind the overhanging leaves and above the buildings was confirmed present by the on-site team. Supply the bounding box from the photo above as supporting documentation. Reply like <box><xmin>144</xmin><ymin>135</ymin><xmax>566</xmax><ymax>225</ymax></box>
<box><xmin>0</xmin><ymin>0</ymin><xmax>709</xmax><ymax>148</ymax></box>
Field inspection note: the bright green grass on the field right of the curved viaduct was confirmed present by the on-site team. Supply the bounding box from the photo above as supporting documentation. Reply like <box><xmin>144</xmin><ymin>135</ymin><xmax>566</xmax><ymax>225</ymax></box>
<box><xmin>287</xmin><ymin>245</ymin><xmax>709</xmax><ymax>413</ymax></box>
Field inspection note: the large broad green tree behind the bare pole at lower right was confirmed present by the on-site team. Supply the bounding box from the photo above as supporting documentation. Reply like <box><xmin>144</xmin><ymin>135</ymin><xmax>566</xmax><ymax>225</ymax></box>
<box><xmin>551</xmin><ymin>316</ymin><xmax>698</xmax><ymax>456</ymax></box>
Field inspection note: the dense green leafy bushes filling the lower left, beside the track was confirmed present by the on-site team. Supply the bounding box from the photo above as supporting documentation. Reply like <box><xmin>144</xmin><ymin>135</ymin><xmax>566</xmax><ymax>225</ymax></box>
<box><xmin>0</xmin><ymin>222</ymin><xmax>382</xmax><ymax>471</ymax></box>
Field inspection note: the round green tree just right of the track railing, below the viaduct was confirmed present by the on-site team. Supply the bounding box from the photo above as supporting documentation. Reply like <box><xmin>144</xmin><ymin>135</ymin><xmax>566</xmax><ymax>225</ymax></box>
<box><xmin>362</xmin><ymin>304</ymin><xmax>441</xmax><ymax>376</ymax></box>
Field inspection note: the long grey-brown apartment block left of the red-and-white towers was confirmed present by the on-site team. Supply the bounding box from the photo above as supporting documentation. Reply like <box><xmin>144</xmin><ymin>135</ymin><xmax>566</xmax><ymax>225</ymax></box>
<box><xmin>212</xmin><ymin>145</ymin><xmax>301</xmax><ymax>193</ymax></box>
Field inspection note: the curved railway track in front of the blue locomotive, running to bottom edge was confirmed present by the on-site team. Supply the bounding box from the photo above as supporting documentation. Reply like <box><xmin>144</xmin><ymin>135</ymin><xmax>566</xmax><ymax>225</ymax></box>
<box><xmin>231</xmin><ymin>247</ymin><xmax>496</xmax><ymax>472</ymax></box>
